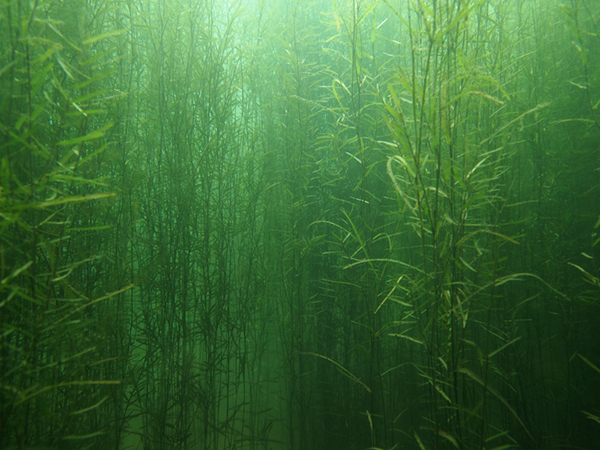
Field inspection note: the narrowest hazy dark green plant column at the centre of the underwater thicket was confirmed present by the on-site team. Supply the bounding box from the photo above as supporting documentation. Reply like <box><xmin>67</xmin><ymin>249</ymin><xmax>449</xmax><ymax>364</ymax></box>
<box><xmin>271</xmin><ymin>1</ymin><xmax>330</xmax><ymax>449</ymax></box>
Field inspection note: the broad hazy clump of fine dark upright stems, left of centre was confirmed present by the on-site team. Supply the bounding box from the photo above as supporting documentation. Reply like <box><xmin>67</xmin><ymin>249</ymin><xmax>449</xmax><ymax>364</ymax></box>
<box><xmin>116</xmin><ymin>2</ymin><xmax>288</xmax><ymax>449</ymax></box>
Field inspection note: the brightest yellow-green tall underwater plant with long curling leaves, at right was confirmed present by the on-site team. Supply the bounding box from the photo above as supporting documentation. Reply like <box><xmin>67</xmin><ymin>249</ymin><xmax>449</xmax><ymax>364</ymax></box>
<box><xmin>386</xmin><ymin>1</ymin><xmax>543</xmax><ymax>448</ymax></box>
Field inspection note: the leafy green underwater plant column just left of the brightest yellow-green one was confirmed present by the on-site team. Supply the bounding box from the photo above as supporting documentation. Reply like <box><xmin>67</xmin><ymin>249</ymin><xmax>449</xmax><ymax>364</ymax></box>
<box><xmin>311</xmin><ymin>1</ymin><xmax>404</xmax><ymax>446</ymax></box>
